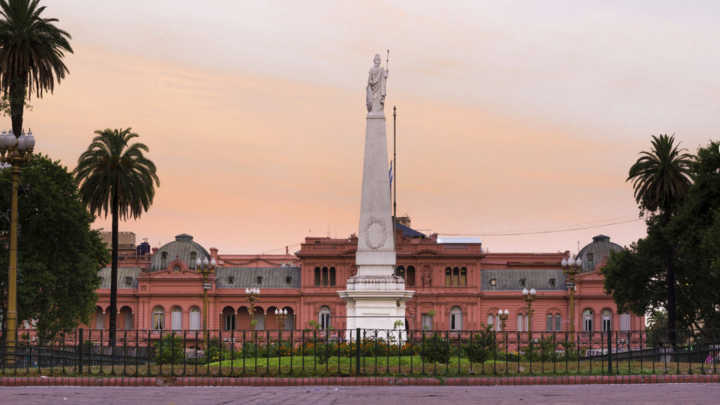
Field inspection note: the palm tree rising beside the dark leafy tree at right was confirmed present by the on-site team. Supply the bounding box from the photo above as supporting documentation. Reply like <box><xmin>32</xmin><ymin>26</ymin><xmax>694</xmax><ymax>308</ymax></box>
<box><xmin>626</xmin><ymin>134</ymin><xmax>694</xmax><ymax>347</ymax></box>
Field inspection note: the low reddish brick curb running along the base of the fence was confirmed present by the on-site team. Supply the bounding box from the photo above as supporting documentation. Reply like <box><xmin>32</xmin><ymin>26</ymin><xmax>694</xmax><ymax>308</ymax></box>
<box><xmin>0</xmin><ymin>374</ymin><xmax>720</xmax><ymax>387</ymax></box>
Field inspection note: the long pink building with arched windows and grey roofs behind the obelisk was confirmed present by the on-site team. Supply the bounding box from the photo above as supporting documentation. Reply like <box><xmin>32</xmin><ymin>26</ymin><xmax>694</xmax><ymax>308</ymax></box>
<box><xmin>89</xmin><ymin>221</ymin><xmax>644</xmax><ymax>332</ymax></box>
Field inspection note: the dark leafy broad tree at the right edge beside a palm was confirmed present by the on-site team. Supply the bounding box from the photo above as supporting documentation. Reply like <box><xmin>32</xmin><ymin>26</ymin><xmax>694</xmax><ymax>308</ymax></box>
<box><xmin>603</xmin><ymin>142</ymin><xmax>720</xmax><ymax>343</ymax></box>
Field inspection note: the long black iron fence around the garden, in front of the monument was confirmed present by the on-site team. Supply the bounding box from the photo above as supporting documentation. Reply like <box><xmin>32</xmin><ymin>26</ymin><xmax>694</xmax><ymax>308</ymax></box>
<box><xmin>0</xmin><ymin>329</ymin><xmax>720</xmax><ymax>377</ymax></box>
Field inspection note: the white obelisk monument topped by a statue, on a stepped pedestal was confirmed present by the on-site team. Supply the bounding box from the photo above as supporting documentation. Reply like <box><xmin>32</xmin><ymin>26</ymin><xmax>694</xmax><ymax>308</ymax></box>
<box><xmin>338</xmin><ymin>55</ymin><xmax>414</xmax><ymax>339</ymax></box>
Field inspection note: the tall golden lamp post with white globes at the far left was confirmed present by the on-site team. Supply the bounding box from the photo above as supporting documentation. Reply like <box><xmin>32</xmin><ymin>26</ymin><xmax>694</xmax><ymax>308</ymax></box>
<box><xmin>0</xmin><ymin>130</ymin><xmax>35</xmax><ymax>365</ymax></box>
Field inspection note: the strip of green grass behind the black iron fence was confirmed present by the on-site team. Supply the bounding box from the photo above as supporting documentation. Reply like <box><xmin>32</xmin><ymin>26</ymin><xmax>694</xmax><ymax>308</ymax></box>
<box><xmin>0</xmin><ymin>355</ymin><xmax>718</xmax><ymax>377</ymax></box>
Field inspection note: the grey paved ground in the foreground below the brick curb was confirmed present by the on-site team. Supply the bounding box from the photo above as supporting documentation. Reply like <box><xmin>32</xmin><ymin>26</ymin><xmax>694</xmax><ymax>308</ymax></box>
<box><xmin>0</xmin><ymin>384</ymin><xmax>720</xmax><ymax>405</ymax></box>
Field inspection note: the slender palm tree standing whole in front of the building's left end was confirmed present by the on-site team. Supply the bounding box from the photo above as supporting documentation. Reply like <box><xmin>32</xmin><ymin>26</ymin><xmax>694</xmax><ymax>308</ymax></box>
<box><xmin>75</xmin><ymin>128</ymin><xmax>160</xmax><ymax>346</ymax></box>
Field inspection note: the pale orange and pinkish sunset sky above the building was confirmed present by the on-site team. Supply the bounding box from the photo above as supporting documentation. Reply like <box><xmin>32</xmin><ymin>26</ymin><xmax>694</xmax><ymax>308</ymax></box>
<box><xmin>19</xmin><ymin>0</ymin><xmax>720</xmax><ymax>253</ymax></box>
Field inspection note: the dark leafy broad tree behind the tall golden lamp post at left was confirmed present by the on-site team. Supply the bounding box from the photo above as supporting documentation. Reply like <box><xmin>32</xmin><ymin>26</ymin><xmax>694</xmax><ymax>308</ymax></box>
<box><xmin>0</xmin><ymin>155</ymin><xmax>109</xmax><ymax>341</ymax></box>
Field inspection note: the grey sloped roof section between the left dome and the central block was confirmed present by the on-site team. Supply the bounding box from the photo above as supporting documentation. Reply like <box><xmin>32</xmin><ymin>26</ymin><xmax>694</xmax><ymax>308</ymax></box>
<box><xmin>215</xmin><ymin>266</ymin><xmax>300</xmax><ymax>289</ymax></box>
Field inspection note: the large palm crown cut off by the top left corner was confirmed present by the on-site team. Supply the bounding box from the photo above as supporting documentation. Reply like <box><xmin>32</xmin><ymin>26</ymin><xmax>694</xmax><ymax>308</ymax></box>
<box><xmin>0</xmin><ymin>0</ymin><xmax>73</xmax><ymax>136</ymax></box>
